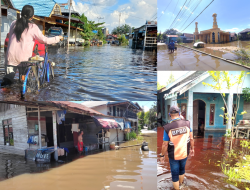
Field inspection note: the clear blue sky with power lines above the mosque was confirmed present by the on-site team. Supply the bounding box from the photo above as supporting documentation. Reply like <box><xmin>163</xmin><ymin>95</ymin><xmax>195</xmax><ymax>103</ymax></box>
<box><xmin>157</xmin><ymin>0</ymin><xmax>250</xmax><ymax>33</ymax></box>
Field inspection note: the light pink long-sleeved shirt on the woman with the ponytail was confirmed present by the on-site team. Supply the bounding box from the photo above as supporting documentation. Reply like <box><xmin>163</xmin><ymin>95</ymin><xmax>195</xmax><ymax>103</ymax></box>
<box><xmin>5</xmin><ymin>21</ymin><xmax>60</xmax><ymax>66</ymax></box>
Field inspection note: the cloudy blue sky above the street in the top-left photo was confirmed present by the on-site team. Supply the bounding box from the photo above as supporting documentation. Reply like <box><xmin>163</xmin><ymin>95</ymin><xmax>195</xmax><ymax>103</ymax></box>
<box><xmin>55</xmin><ymin>0</ymin><xmax>157</xmax><ymax>33</ymax></box>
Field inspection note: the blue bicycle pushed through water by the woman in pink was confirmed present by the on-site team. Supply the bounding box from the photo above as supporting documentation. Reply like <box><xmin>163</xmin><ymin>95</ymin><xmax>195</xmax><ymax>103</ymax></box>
<box><xmin>17</xmin><ymin>45</ymin><xmax>55</xmax><ymax>97</ymax></box>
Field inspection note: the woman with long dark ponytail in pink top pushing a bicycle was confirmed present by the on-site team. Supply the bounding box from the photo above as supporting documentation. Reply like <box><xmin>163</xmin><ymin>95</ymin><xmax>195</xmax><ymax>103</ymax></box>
<box><xmin>1</xmin><ymin>5</ymin><xmax>63</xmax><ymax>86</ymax></box>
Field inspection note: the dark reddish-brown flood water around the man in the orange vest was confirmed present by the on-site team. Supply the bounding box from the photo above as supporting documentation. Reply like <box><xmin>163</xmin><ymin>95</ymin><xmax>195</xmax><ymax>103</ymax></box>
<box><xmin>157</xmin><ymin>127</ymin><xmax>250</xmax><ymax>190</ymax></box>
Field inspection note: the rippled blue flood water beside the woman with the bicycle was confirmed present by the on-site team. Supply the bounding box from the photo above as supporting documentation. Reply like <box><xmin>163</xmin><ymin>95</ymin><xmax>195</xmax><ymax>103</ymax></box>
<box><xmin>0</xmin><ymin>45</ymin><xmax>157</xmax><ymax>101</ymax></box>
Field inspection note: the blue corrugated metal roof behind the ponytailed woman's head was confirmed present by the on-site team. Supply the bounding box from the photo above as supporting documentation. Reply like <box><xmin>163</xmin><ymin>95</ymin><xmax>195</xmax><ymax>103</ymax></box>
<box><xmin>12</xmin><ymin>0</ymin><xmax>56</xmax><ymax>17</ymax></box>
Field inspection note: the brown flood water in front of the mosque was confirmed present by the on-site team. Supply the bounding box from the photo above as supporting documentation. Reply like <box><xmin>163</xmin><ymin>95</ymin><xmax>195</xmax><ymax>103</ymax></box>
<box><xmin>157</xmin><ymin>41</ymin><xmax>249</xmax><ymax>71</ymax></box>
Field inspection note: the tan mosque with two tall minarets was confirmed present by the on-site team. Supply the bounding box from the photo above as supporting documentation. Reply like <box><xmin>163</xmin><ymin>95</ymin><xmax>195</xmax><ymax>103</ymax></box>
<box><xmin>194</xmin><ymin>13</ymin><xmax>230</xmax><ymax>44</ymax></box>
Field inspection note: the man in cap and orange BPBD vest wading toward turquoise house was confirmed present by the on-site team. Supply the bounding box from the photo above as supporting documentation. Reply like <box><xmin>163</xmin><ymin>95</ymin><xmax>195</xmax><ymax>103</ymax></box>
<box><xmin>160</xmin><ymin>106</ymin><xmax>194</xmax><ymax>190</ymax></box>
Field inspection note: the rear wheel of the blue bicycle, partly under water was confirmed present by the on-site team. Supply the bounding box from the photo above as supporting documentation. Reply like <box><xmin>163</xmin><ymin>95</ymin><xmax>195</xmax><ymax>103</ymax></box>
<box><xmin>23</xmin><ymin>67</ymin><xmax>39</xmax><ymax>94</ymax></box>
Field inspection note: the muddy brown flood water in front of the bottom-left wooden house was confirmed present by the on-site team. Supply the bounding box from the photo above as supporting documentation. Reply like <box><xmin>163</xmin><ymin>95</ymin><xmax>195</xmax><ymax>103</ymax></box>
<box><xmin>0</xmin><ymin>133</ymin><xmax>157</xmax><ymax>190</ymax></box>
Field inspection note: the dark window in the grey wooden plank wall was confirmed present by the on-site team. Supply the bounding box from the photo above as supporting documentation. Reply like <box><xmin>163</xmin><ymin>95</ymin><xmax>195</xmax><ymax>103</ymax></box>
<box><xmin>2</xmin><ymin>119</ymin><xmax>14</xmax><ymax>146</ymax></box>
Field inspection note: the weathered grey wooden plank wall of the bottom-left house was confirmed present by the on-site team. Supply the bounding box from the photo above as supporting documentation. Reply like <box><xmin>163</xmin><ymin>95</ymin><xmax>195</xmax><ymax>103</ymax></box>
<box><xmin>0</xmin><ymin>103</ymin><xmax>28</xmax><ymax>150</ymax></box>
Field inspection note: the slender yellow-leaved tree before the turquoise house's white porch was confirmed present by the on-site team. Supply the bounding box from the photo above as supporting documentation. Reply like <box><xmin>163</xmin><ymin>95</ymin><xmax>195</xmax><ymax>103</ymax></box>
<box><xmin>202</xmin><ymin>71</ymin><xmax>250</xmax><ymax>137</ymax></box>
